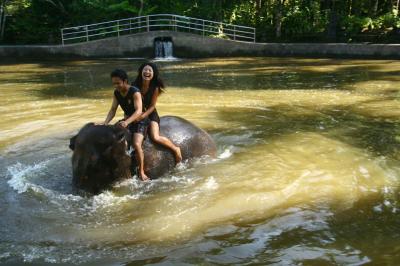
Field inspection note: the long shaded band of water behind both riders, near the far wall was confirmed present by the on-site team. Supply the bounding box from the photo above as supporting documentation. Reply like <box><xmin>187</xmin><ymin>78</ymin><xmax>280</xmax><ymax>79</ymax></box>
<box><xmin>2</xmin><ymin>58</ymin><xmax>400</xmax><ymax>98</ymax></box>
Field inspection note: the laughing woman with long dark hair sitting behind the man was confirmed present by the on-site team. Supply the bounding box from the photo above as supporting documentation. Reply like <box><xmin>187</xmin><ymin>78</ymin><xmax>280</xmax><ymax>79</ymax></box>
<box><xmin>132</xmin><ymin>63</ymin><xmax>182</xmax><ymax>180</ymax></box>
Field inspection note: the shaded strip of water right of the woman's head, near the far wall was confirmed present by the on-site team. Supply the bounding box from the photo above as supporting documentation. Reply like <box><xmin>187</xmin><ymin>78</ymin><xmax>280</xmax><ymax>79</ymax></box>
<box><xmin>164</xmin><ymin>58</ymin><xmax>400</xmax><ymax>90</ymax></box>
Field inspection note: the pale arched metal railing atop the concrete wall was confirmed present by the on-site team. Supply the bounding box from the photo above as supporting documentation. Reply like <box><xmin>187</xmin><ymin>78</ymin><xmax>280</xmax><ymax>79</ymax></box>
<box><xmin>61</xmin><ymin>14</ymin><xmax>256</xmax><ymax>45</ymax></box>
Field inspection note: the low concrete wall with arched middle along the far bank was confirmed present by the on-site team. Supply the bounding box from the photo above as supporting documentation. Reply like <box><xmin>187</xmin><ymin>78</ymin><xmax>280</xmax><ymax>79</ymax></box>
<box><xmin>0</xmin><ymin>31</ymin><xmax>400</xmax><ymax>58</ymax></box>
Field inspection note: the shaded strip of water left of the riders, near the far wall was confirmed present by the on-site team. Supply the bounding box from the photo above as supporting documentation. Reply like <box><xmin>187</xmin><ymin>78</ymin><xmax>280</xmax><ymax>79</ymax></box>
<box><xmin>0</xmin><ymin>59</ymin><xmax>148</xmax><ymax>99</ymax></box>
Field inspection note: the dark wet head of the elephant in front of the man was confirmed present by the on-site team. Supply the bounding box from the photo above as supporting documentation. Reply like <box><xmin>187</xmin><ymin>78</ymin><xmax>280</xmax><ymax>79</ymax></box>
<box><xmin>69</xmin><ymin>123</ymin><xmax>131</xmax><ymax>194</ymax></box>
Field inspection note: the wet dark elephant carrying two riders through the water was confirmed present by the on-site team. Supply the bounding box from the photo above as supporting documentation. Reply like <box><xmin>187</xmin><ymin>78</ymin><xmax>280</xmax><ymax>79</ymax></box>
<box><xmin>69</xmin><ymin>116</ymin><xmax>217</xmax><ymax>194</ymax></box>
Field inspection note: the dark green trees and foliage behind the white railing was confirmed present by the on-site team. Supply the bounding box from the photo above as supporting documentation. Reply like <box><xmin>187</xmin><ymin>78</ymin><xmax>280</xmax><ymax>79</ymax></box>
<box><xmin>0</xmin><ymin>0</ymin><xmax>400</xmax><ymax>44</ymax></box>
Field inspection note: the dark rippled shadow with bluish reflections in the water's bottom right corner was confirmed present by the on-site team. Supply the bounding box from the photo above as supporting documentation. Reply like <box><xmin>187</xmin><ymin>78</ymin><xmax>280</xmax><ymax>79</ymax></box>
<box><xmin>197</xmin><ymin>192</ymin><xmax>400</xmax><ymax>265</ymax></box>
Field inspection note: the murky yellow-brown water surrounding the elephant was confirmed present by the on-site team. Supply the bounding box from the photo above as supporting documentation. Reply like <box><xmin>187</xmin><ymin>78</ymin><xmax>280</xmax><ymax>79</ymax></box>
<box><xmin>0</xmin><ymin>58</ymin><xmax>400</xmax><ymax>265</ymax></box>
